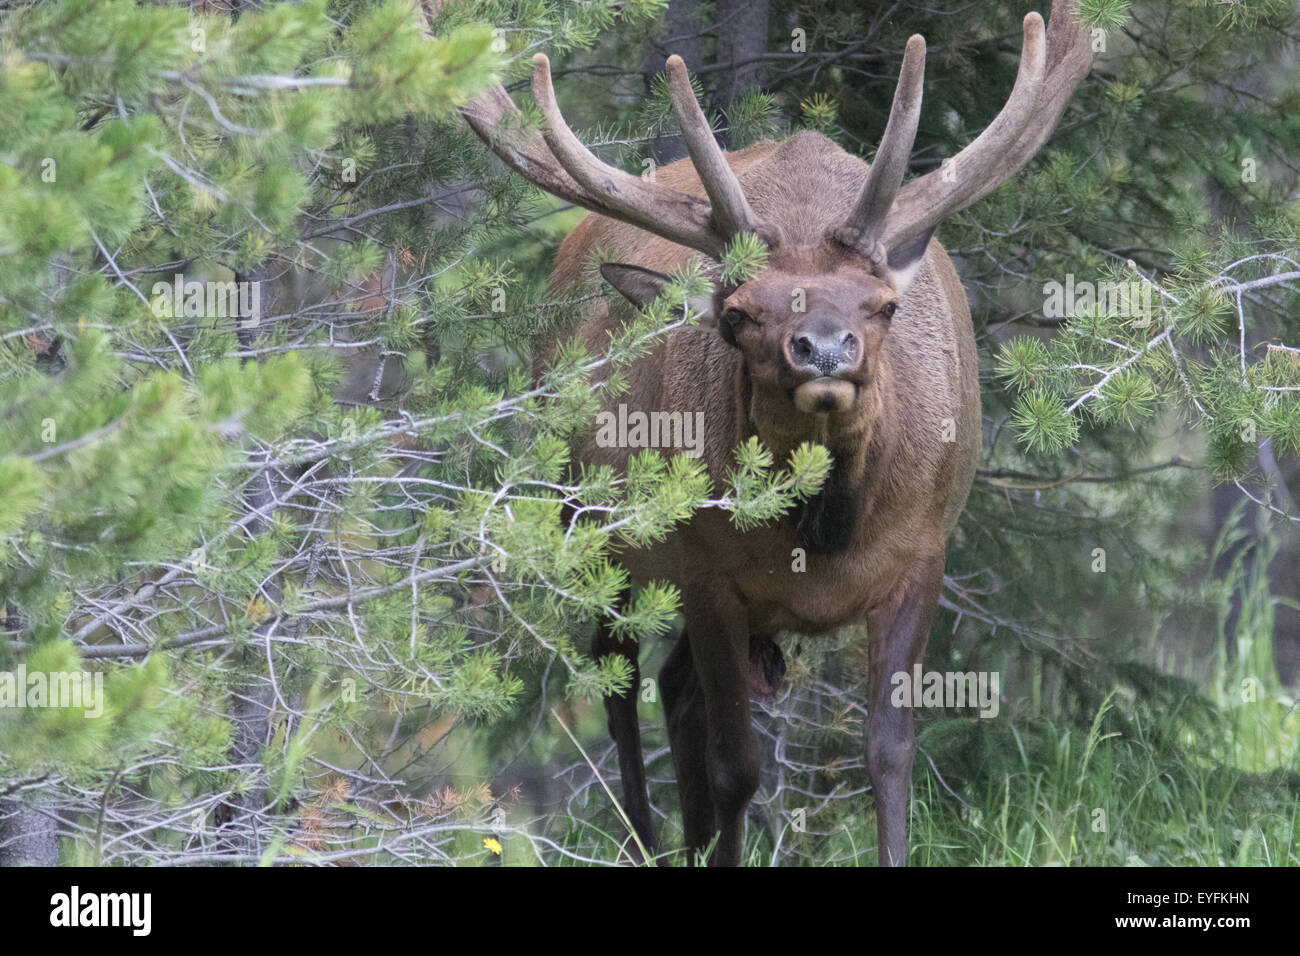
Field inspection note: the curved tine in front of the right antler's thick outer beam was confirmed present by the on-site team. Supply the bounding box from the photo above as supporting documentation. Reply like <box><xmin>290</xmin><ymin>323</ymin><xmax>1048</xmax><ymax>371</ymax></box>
<box><xmin>883</xmin><ymin>13</ymin><xmax>1063</xmax><ymax>247</ymax></box>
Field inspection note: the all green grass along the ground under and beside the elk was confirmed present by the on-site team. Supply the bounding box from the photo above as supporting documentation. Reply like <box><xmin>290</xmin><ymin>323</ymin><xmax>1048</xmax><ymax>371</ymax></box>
<box><xmin>522</xmin><ymin>681</ymin><xmax>1300</xmax><ymax>866</ymax></box>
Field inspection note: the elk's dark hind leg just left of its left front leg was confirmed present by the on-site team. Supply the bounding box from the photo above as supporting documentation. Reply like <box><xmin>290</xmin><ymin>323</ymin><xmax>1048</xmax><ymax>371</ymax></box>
<box><xmin>659</xmin><ymin>631</ymin><xmax>718</xmax><ymax>866</ymax></box>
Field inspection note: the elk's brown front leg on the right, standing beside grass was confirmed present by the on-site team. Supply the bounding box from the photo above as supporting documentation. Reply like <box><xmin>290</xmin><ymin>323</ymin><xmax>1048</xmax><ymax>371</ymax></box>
<box><xmin>867</xmin><ymin>555</ymin><xmax>944</xmax><ymax>866</ymax></box>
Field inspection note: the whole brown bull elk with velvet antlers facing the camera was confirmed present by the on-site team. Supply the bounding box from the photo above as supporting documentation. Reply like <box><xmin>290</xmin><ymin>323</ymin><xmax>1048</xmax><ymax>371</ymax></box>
<box><xmin>463</xmin><ymin>0</ymin><xmax>1092</xmax><ymax>865</ymax></box>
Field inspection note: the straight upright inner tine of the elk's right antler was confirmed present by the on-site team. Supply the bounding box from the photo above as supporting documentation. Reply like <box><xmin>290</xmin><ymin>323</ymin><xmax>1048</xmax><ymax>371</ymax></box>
<box><xmin>836</xmin><ymin>34</ymin><xmax>926</xmax><ymax>264</ymax></box>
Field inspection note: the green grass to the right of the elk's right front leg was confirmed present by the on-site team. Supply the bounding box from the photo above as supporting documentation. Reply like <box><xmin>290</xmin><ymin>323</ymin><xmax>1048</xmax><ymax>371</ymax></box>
<box><xmin>910</xmin><ymin>705</ymin><xmax>1300</xmax><ymax>866</ymax></box>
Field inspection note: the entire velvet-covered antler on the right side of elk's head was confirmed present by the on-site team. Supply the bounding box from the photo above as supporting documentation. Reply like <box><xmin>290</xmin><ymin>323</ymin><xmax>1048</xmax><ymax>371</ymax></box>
<box><xmin>835</xmin><ymin>0</ymin><xmax>1092</xmax><ymax>265</ymax></box>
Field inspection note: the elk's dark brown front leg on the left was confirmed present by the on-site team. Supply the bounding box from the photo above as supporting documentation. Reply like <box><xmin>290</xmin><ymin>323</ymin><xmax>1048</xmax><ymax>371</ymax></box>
<box><xmin>684</xmin><ymin>592</ymin><xmax>759</xmax><ymax>866</ymax></box>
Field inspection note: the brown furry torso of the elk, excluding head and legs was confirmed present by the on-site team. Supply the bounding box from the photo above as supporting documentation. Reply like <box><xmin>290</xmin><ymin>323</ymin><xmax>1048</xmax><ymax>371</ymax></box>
<box><xmin>538</xmin><ymin>133</ymin><xmax>980</xmax><ymax>616</ymax></box>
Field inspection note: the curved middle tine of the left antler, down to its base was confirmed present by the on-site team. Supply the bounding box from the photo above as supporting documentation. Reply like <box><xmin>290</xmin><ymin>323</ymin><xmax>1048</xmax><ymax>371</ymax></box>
<box><xmin>533</xmin><ymin>53</ymin><xmax>724</xmax><ymax>258</ymax></box>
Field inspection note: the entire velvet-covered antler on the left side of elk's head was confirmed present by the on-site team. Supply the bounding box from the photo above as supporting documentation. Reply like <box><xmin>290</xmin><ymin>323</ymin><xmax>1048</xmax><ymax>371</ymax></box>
<box><xmin>460</xmin><ymin>53</ymin><xmax>759</xmax><ymax>259</ymax></box>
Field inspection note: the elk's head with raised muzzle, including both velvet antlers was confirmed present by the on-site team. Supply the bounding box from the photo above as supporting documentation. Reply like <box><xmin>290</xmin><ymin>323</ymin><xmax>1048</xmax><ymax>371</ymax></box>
<box><xmin>463</xmin><ymin>0</ymin><xmax>1091</xmax><ymax>423</ymax></box>
